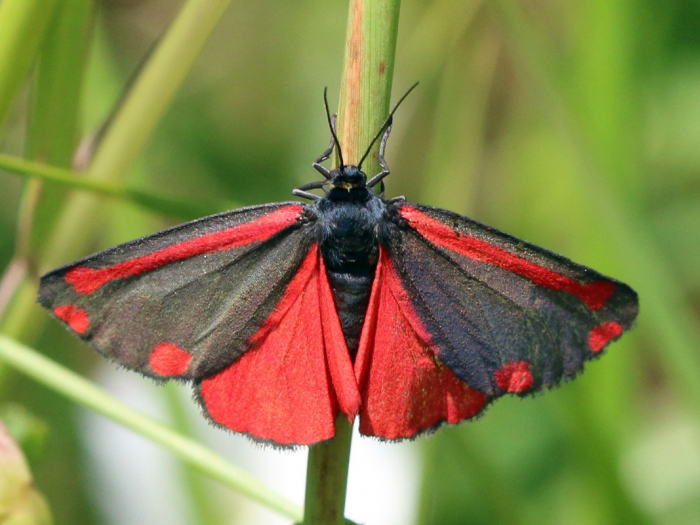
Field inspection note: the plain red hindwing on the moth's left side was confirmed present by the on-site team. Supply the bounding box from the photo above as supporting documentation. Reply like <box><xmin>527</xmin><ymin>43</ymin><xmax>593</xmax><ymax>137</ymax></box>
<box><xmin>201</xmin><ymin>245</ymin><xmax>359</xmax><ymax>444</ymax></box>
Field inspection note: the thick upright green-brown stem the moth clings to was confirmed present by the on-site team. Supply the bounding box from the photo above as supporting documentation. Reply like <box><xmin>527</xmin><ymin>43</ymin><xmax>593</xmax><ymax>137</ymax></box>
<box><xmin>304</xmin><ymin>0</ymin><xmax>401</xmax><ymax>525</ymax></box>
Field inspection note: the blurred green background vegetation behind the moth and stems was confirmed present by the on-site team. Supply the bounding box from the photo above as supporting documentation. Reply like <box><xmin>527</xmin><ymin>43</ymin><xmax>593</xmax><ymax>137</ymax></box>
<box><xmin>0</xmin><ymin>0</ymin><xmax>700</xmax><ymax>525</ymax></box>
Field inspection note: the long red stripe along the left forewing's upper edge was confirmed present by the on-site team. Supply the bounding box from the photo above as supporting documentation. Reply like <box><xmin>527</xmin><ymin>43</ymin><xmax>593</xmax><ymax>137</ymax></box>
<box><xmin>65</xmin><ymin>205</ymin><xmax>302</xmax><ymax>294</ymax></box>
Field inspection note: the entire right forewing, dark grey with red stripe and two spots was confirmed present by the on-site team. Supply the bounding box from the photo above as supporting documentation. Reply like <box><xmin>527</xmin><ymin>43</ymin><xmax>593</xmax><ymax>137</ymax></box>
<box><xmin>385</xmin><ymin>204</ymin><xmax>638</xmax><ymax>397</ymax></box>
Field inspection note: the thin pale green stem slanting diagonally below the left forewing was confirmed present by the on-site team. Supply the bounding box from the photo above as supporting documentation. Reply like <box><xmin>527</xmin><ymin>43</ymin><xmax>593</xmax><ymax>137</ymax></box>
<box><xmin>0</xmin><ymin>335</ymin><xmax>302</xmax><ymax>520</ymax></box>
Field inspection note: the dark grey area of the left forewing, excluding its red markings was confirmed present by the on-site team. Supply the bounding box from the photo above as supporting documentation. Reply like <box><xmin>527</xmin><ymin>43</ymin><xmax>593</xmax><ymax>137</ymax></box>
<box><xmin>39</xmin><ymin>203</ymin><xmax>313</xmax><ymax>378</ymax></box>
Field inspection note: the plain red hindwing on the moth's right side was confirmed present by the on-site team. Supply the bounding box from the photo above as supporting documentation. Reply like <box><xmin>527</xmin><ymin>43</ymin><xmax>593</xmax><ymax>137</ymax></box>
<box><xmin>355</xmin><ymin>248</ymin><xmax>486</xmax><ymax>439</ymax></box>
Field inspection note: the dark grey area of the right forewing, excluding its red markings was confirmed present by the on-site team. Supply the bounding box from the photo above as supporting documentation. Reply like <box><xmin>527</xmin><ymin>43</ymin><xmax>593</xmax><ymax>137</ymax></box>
<box><xmin>385</xmin><ymin>204</ymin><xmax>638</xmax><ymax>396</ymax></box>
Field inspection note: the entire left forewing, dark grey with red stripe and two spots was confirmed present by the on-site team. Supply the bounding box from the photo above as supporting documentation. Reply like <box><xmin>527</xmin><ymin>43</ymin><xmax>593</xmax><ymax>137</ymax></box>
<box><xmin>39</xmin><ymin>203</ymin><xmax>312</xmax><ymax>378</ymax></box>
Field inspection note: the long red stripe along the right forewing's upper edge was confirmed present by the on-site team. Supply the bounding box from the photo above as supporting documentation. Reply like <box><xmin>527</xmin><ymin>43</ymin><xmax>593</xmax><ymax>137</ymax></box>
<box><xmin>400</xmin><ymin>206</ymin><xmax>615</xmax><ymax>310</ymax></box>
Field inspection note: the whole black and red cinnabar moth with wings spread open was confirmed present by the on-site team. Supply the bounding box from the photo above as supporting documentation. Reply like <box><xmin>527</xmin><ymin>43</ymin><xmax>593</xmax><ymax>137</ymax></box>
<box><xmin>39</xmin><ymin>88</ymin><xmax>638</xmax><ymax>444</ymax></box>
